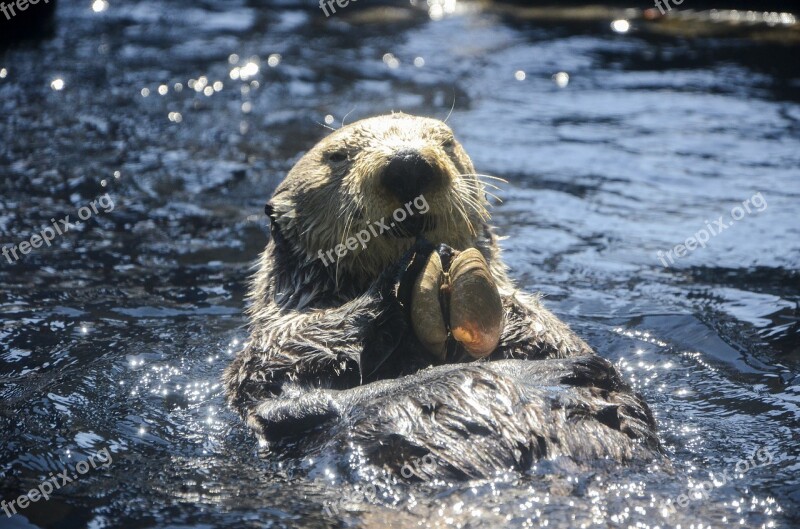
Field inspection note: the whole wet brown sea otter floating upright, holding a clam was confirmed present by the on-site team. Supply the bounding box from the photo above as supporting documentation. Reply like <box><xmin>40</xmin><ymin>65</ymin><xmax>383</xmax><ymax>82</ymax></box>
<box><xmin>224</xmin><ymin>113</ymin><xmax>660</xmax><ymax>477</ymax></box>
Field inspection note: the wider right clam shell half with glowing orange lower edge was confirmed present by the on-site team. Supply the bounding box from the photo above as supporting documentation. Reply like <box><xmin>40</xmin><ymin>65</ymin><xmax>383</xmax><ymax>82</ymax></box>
<box><xmin>449</xmin><ymin>248</ymin><xmax>503</xmax><ymax>358</ymax></box>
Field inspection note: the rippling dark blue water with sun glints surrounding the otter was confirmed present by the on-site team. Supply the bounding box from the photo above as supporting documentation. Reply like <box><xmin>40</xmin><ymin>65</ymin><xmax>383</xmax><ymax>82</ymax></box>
<box><xmin>0</xmin><ymin>0</ymin><xmax>800</xmax><ymax>529</ymax></box>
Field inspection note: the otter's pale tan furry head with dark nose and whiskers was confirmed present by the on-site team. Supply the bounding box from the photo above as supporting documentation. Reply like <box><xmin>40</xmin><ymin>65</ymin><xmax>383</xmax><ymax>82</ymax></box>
<box><xmin>271</xmin><ymin>114</ymin><xmax>489</xmax><ymax>283</ymax></box>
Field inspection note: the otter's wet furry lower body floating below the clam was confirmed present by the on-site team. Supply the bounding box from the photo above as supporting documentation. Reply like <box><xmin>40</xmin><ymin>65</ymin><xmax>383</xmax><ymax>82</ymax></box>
<box><xmin>251</xmin><ymin>356</ymin><xmax>660</xmax><ymax>479</ymax></box>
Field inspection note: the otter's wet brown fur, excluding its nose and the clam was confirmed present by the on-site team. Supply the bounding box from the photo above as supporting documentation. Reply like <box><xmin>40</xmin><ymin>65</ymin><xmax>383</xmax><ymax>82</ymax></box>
<box><xmin>224</xmin><ymin>114</ymin><xmax>658</xmax><ymax>476</ymax></box>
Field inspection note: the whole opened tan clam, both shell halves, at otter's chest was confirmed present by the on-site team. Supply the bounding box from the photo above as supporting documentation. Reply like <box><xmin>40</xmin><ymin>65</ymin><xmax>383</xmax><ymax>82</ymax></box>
<box><xmin>410</xmin><ymin>247</ymin><xmax>503</xmax><ymax>361</ymax></box>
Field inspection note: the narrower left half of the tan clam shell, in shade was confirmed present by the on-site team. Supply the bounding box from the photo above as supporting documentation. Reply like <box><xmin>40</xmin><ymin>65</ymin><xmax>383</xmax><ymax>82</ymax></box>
<box><xmin>411</xmin><ymin>252</ymin><xmax>447</xmax><ymax>361</ymax></box>
